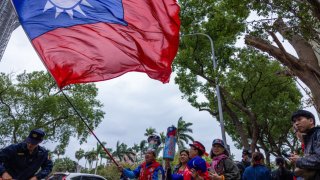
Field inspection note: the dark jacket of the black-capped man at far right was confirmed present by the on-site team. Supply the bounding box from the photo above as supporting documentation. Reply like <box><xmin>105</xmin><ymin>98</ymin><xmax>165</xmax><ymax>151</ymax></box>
<box><xmin>296</xmin><ymin>127</ymin><xmax>320</xmax><ymax>179</ymax></box>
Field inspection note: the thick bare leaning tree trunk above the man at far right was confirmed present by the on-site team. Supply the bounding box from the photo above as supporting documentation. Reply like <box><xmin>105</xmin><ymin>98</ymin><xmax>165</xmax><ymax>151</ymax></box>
<box><xmin>245</xmin><ymin>31</ymin><xmax>320</xmax><ymax>112</ymax></box>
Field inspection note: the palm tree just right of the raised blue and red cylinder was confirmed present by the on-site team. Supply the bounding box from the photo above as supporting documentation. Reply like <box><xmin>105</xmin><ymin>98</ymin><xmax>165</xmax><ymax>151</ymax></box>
<box><xmin>177</xmin><ymin>117</ymin><xmax>194</xmax><ymax>151</ymax></box>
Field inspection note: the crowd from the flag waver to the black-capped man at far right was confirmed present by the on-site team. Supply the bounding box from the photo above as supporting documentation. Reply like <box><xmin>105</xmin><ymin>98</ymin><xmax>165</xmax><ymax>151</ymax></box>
<box><xmin>119</xmin><ymin>110</ymin><xmax>320</xmax><ymax>180</ymax></box>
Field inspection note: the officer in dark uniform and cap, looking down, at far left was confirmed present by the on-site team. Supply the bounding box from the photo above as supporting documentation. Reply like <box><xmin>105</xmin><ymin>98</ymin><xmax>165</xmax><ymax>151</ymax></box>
<box><xmin>0</xmin><ymin>129</ymin><xmax>53</xmax><ymax>180</ymax></box>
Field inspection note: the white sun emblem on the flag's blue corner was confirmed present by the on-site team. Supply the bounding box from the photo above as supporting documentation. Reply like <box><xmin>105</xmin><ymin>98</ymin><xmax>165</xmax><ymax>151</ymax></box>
<box><xmin>43</xmin><ymin>0</ymin><xmax>92</xmax><ymax>18</ymax></box>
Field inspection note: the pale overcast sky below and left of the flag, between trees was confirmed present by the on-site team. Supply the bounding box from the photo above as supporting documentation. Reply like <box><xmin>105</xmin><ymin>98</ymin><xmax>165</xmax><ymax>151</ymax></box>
<box><xmin>0</xmin><ymin>27</ymin><xmax>241</xmax><ymax>166</ymax></box>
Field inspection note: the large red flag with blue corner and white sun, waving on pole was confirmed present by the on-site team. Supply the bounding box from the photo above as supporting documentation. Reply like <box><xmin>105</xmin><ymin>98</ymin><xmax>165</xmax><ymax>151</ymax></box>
<box><xmin>12</xmin><ymin>0</ymin><xmax>180</xmax><ymax>88</ymax></box>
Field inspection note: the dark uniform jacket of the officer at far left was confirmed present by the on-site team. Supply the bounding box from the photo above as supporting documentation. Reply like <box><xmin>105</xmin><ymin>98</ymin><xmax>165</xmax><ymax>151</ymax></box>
<box><xmin>0</xmin><ymin>142</ymin><xmax>53</xmax><ymax>180</ymax></box>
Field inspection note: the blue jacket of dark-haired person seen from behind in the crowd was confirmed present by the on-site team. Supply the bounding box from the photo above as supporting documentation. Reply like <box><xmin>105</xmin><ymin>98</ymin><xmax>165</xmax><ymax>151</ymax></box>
<box><xmin>242</xmin><ymin>165</ymin><xmax>271</xmax><ymax>180</ymax></box>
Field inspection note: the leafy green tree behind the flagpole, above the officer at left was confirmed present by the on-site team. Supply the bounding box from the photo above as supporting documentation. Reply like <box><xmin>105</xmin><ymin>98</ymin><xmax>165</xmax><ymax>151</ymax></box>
<box><xmin>0</xmin><ymin>71</ymin><xmax>104</xmax><ymax>146</ymax></box>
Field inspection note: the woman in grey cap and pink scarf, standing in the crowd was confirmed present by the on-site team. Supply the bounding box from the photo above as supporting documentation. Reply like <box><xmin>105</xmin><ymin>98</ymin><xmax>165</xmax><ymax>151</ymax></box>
<box><xmin>209</xmin><ymin>139</ymin><xmax>240</xmax><ymax>180</ymax></box>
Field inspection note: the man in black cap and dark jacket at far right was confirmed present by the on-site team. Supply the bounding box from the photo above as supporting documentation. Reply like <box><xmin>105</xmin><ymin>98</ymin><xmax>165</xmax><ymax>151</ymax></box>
<box><xmin>289</xmin><ymin>110</ymin><xmax>320</xmax><ymax>179</ymax></box>
